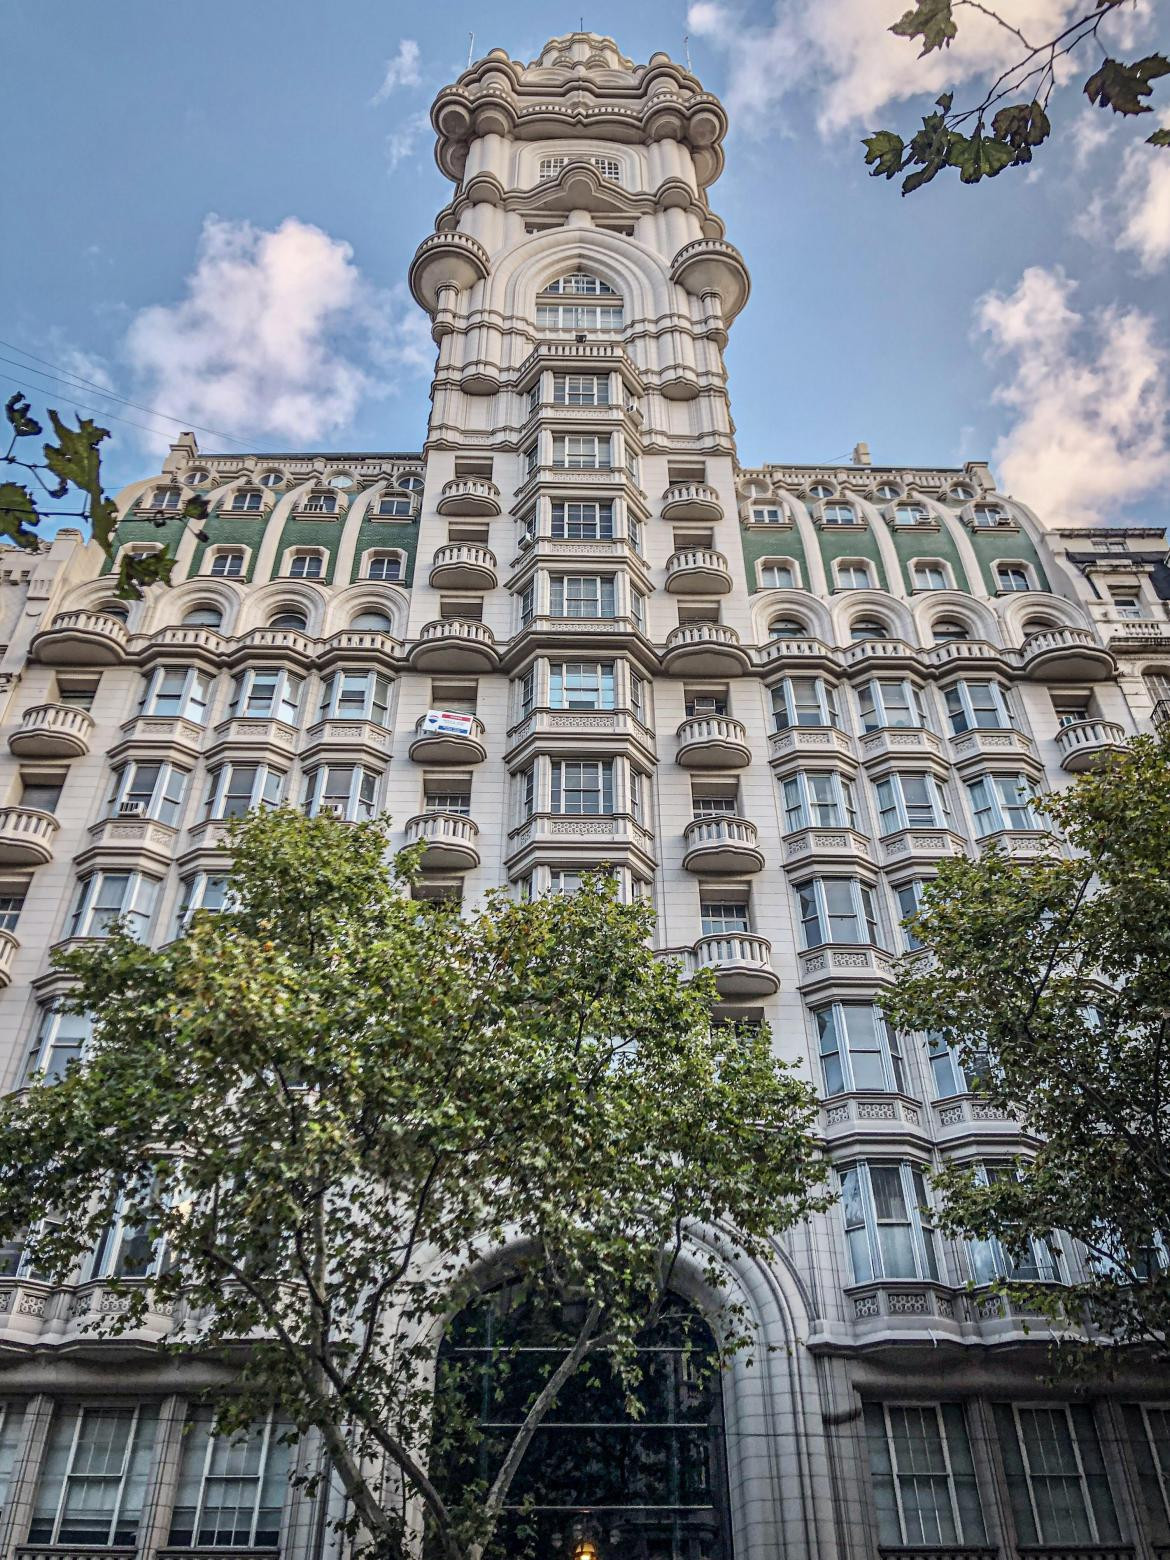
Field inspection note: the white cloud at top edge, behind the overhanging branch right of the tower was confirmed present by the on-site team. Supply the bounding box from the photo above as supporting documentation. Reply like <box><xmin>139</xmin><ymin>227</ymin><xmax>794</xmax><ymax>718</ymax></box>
<box><xmin>686</xmin><ymin>0</ymin><xmax>1083</xmax><ymax>136</ymax></box>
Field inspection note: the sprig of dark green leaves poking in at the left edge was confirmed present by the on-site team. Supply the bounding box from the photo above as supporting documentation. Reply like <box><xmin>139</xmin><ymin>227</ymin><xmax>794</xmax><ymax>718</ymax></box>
<box><xmin>0</xmin><ymin>392</ymin><xmax>207</xmax><ymax>601</ymax></box>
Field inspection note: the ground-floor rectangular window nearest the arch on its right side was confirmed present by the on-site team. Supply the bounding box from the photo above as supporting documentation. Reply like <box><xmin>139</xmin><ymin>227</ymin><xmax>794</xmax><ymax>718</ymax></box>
<box><xmin>866</xmin><ymin>1402</ymin><xmax>987</xmax><ymax>1548</ymax></box>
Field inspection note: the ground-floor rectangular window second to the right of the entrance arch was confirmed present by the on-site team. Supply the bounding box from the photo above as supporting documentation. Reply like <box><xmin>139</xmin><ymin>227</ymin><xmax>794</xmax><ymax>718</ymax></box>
<box><xmin>995</xmin><ymin>1402</ymin><xmax>1120</xmax><ymax>1546</ymax></box>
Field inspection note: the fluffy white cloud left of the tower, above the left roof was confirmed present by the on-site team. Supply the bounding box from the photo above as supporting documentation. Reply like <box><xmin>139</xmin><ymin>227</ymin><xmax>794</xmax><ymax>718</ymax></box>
<box><xmin>125</xmin><ymin>215</ymin><xmax>431</xmax><ymax>446</ymax></box>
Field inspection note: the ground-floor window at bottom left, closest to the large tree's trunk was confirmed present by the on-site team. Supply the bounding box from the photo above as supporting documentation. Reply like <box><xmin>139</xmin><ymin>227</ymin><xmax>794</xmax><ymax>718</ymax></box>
<box><xmin>170</xmin><ymin>1409</ymin><xmax>289</xmax><ymax>1549</ymax></box>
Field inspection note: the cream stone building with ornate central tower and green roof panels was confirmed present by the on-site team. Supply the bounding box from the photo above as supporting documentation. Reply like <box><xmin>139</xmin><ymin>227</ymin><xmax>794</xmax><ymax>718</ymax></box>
<box><xmin>0</xmin><ymin>33</ymin><xmax>1170</xmax><ymax>1560</ymax></box>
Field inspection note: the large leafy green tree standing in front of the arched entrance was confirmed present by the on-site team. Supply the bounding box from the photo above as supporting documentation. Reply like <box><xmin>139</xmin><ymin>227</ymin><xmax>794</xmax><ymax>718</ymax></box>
<box><xmin>0</xmin><ymin>810</ymin><xmax>825</xmax><ymax>1560</ymax></box>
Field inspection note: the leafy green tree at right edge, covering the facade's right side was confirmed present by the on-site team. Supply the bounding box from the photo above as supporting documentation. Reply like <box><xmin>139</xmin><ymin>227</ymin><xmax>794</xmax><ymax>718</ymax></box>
<box><xmin>885</xmin><ymin>736</ymin><xmax>1170</xmax><ymax>1354</ymax></box>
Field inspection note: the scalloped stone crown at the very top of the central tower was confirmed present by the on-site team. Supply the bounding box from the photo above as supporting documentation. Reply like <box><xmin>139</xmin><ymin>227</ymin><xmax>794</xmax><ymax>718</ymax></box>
<box><xmin>431</xmin><ymin>33</ymin><xmax>727</xmax><ymax>193</ymax></box>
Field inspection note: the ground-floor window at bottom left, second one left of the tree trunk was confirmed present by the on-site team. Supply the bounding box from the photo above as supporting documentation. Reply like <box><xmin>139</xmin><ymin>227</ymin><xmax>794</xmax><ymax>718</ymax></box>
<box><xmin>28</xmin><ymin>1407</ymin><xmax>158</xmax><ymax>1546</ymax></box>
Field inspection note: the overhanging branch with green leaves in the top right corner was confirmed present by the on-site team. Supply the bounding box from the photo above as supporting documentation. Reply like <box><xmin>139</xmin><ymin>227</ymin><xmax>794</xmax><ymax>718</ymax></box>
<box><xmin>863</xmin><ymin>0</ymin><xmax>1170</xmax><ymax>195</ymax></box>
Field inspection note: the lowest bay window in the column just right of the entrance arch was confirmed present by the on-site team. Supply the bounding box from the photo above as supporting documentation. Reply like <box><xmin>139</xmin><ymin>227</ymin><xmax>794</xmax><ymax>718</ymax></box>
<box><xmin>839</xmin><ymin>1161</ymin><xmax>939</xmax><ymax>1284</ymax></box>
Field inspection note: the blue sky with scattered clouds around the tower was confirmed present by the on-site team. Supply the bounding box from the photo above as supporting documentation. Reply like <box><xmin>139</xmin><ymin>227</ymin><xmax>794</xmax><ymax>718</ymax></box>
<box><xmin>0</xmin><ymin>0</ymin><xmax>1170</xmax><ymax>524</ymax></box>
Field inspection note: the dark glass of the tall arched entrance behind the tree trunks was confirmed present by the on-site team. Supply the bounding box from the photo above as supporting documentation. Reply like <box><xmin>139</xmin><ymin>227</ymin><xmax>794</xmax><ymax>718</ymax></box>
<box><xmin>434</xmin><ymin>1284</ymin><xmax>732</xmax><ymax>1560</ymax></box>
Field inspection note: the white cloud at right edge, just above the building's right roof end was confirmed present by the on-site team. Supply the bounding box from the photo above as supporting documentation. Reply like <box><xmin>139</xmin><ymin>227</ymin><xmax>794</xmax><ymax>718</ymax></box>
<box><xmin>977</xmin><ymin>265</ymin><xmax>1170</xmax><ymax>524</ymax></box>
